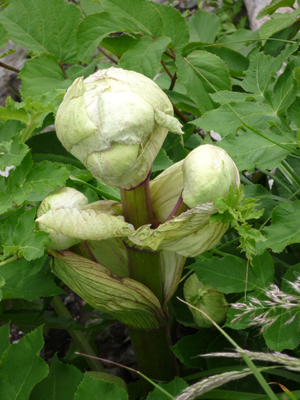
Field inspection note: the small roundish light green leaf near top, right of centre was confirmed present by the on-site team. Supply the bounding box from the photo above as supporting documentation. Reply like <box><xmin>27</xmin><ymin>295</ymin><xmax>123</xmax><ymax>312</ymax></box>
<box><xmin>188</xmin><ymin>10</ymin><xmax>220</xmax><ymax>43</ymax></box>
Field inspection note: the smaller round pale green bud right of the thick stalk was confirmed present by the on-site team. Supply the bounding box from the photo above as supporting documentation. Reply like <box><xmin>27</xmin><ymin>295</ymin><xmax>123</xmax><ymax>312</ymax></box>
<box><xmin>182</xmin><ymin>144</ymin><xmax>240</xmax><ymax>208</ymax></box>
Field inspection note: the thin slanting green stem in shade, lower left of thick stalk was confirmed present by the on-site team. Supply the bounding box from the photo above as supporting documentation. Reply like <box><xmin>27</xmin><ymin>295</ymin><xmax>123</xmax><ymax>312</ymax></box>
<box><xmin>51</xmin><ymin>295</ymin><xmax>105</xmax><ymax>372</ymax></box>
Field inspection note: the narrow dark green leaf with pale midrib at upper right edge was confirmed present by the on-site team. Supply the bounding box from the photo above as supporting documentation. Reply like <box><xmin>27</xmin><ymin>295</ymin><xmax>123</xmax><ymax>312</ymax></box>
<box><xmin>272</xmin><ymin>57</ymin><xmax>299</xmax><ymax>114</ymax></box>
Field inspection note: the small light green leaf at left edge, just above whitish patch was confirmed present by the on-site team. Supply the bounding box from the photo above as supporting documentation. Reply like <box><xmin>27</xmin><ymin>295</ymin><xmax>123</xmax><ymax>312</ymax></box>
<box><xmin>0</xmin><ymin>135</ymin><xmax>29</xmax><ymax>170</ymax></box>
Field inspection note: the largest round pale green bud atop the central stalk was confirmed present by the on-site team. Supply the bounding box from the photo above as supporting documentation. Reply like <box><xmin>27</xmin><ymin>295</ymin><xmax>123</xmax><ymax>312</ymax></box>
<box><xmin>55</xmin><ymin>67</ymin><xmax>183</xmax><ymax>189</ymax></box>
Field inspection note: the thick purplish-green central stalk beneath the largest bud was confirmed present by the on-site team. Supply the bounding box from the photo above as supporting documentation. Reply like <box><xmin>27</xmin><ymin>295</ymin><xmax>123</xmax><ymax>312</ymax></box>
<box><xmin>121</xmin><ymin>174</ymin><xmax>178</xmax><ymax>384</ymax></box>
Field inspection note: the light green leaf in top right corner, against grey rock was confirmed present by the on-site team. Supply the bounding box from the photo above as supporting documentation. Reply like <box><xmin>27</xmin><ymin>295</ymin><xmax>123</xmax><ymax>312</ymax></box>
<box><xmin>258</xmin><ymin>9</ymin><xmax>299</xmax><ymax>44</ymax></box>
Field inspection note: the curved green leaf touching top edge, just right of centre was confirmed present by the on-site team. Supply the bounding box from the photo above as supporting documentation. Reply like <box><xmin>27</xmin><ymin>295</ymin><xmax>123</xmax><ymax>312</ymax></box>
<box><xmin>153</xmin><ymin>3</ymin><xmax>190</xmax><ymax>53</ymax></box>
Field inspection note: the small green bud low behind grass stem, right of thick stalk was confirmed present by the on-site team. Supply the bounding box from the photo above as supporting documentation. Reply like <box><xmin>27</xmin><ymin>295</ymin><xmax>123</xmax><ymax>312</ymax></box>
<box><xmin>183</xmin><ymin>274</ymin><xmax>228</xmax><ymax>328</ymax></box>
